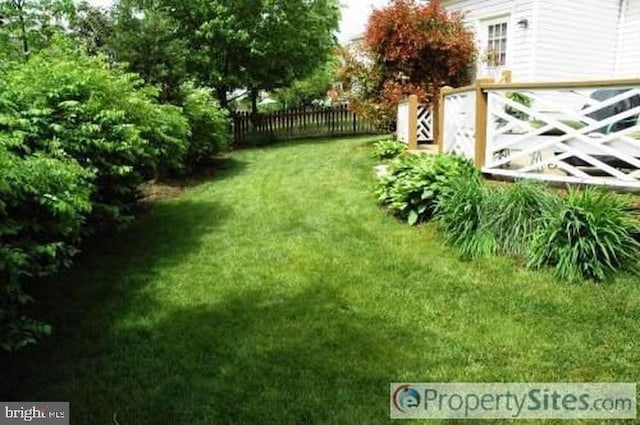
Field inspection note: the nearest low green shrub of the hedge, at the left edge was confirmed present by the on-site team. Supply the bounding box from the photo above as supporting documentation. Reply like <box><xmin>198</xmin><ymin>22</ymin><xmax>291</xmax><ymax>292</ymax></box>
<box><xmin>0</xmin><ymin>146</ymin><xmax>92</xmax><ymax>351</ymax></box>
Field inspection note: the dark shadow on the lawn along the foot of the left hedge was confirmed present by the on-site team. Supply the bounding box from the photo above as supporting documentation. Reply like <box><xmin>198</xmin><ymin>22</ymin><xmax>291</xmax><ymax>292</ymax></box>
<box><xmin>0</xmin><ymin>200</ymin><xmax>229</xmax><ymax>400</ymax></box>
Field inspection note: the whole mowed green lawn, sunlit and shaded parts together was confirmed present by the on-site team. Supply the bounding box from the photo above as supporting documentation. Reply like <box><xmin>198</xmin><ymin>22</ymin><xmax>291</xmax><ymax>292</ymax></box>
<box><xmin>0</xmin><ymin>138</ymin><xmax>640</xmax><ymax>425</ymax></box>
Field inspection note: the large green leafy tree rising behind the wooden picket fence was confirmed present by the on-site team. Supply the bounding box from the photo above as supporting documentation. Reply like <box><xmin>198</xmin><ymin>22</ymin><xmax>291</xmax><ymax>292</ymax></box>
<box><xmin>123</xmin><ymin>0</ymin><xmax>340</xmax><ymax>108</ymax></box>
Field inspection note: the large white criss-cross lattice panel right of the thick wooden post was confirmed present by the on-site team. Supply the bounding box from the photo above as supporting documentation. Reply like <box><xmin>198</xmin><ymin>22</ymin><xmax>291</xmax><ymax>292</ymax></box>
<box><xmin>484</xmin><ymin>83</ymin><xmax>640</xmax><ymax>188</ymax></box>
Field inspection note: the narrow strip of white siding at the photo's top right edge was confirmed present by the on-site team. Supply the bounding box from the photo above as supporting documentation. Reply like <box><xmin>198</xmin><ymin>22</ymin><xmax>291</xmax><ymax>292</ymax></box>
<box><xmin>617</xmin><ymin>0</ymin><xmax>640</xmax><ymax>78</ymax></box>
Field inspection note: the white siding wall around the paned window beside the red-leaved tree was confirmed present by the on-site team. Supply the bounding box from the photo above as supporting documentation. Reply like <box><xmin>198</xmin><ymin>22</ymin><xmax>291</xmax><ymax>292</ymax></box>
<box><xmin>443</xmin><ymin>0</ymin><xmax>537</xmax><ymax>82</ymax></box>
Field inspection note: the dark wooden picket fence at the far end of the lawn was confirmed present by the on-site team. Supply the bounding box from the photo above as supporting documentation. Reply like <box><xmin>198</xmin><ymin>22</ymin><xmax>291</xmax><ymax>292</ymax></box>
<box><xmin>233</xmin><ymin>105</ymin><xmax>380</xmax><ymax>147</ymax></box>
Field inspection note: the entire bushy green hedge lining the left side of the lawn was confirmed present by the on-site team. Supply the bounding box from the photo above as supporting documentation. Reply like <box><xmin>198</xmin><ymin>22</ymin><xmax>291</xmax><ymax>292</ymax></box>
<box><xmin>0</xmin><ymin>43</ymin><xmax>229</xmax><ymax>351</ymax></box>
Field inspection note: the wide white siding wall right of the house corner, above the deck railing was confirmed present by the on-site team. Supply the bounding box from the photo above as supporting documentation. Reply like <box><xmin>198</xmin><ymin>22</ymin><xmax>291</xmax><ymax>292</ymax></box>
<box><xmin>534</xmin><ymin>0</ymin><xmax>620</xmax><ymax>81</ymax></box>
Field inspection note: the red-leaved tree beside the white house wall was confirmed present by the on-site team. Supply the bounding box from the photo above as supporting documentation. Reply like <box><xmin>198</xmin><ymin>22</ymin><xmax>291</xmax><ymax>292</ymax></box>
<box><xmin>343</xmin><ymin>0</ymin><xmax>476</xmax><ymax>123</ymax></box>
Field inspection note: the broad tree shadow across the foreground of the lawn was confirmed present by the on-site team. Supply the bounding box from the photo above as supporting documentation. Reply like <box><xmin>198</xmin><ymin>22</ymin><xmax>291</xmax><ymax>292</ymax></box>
<box><xmin>40</xmin><ymin>287</ymin><xmax>424</xmax><ymax>424</ymax></box>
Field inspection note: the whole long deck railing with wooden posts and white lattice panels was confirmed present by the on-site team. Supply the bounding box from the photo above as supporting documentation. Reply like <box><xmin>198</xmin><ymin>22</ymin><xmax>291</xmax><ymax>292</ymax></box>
<box><xmin>420</xmin><ymin>75</ymin><xmax>640</xmax><ymax>189</ymax></box>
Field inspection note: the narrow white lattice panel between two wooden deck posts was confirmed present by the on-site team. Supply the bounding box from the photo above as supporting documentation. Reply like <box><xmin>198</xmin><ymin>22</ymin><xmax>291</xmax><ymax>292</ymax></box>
<box><xmin>442</xmin><ymin>88</ymin><xmax>476</xmax><ymax>160</ymax></box>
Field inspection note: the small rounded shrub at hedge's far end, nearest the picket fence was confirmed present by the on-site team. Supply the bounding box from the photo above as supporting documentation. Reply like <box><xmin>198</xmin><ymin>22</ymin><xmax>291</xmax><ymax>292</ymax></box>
<box><xmin>182</xmin><ymin>84</ymin><xmax>230</xmax><ymax>168</ymax></box>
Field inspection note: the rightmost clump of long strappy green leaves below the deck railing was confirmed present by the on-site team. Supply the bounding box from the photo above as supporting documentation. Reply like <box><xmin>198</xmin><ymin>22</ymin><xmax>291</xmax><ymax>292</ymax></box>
<box><xmin>528</xmin><ymin>189</ymin><xmax>640</xmax><ymax>281</ymax></box>
